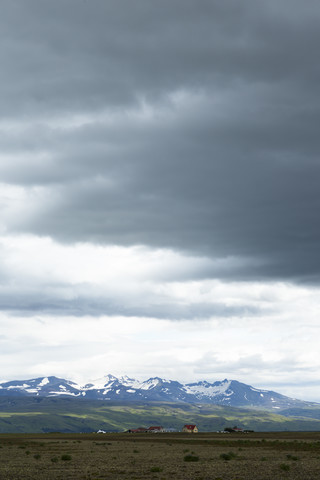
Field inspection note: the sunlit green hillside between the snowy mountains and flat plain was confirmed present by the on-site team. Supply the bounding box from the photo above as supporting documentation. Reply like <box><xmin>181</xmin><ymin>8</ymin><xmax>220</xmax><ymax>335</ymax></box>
<box><xmin>0</xmin><ymin>397</ymin><xmax>320</xmax><ymax>433</ymax></box>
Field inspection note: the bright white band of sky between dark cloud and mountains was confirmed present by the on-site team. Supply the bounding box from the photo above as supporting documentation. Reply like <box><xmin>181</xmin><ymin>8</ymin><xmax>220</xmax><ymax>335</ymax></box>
<box><xmin>0</xmin><ymin>237</ymin><xmax>320</xmax><ymax>400</ymax></box>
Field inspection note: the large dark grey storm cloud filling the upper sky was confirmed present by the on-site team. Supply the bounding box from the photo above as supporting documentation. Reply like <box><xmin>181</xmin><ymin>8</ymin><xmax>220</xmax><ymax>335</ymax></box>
<box><xmin>0</xmin><ymin>0</ymin><xmax>320</xmax><ymax>282</ymax></box>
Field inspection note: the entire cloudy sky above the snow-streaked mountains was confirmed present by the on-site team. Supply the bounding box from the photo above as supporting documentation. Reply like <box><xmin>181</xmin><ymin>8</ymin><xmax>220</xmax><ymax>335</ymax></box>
<box><xmin>0</xmin><ymin>0</ymin><xmax>320</xmax><ymax>402</ymax></box>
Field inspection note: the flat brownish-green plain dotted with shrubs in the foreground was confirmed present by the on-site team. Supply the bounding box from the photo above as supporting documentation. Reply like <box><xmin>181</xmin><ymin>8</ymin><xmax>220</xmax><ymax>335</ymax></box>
<box><xmin>0</xmin><ymin>432</ymin><xmax>320</xmax><ymax>480</ymax></box>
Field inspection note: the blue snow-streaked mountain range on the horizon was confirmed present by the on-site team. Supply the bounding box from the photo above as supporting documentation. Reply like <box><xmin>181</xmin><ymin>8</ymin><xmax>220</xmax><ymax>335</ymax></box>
<box><xmin>0</xmin><ymin>375</ymin><xmax>317</xmax><ymax>410</ymax></box>
